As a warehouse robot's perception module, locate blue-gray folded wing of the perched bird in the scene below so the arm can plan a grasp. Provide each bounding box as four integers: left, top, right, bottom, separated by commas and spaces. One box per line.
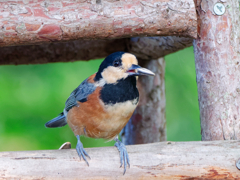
65, 79, 96, 111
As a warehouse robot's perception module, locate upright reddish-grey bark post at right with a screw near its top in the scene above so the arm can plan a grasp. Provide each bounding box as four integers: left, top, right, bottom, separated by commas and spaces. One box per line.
194, 0, 240, 140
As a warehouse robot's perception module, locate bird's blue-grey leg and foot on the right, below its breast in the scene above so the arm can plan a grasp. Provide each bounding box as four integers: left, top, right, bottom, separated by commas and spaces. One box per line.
114, 136, 130, 174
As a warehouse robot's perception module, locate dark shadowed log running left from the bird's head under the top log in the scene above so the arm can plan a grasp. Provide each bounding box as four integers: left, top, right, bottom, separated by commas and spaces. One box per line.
0, 39, 126, 65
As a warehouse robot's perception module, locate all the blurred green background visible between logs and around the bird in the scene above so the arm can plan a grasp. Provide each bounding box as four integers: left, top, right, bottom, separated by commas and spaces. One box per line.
0, 47, 201, 151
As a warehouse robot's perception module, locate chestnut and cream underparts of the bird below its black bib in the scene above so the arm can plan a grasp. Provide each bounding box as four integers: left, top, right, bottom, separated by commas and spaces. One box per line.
67, 87, 137, 139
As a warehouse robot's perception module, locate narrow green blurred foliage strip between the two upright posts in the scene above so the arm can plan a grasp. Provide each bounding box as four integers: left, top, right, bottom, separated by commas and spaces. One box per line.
165, 47, 201, 141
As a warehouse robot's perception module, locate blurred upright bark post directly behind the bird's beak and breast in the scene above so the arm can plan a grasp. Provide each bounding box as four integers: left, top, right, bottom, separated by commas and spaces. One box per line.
122, 58, 167, 144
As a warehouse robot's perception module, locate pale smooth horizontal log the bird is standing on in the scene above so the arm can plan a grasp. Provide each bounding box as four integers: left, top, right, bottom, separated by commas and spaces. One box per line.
0, 141, 240, 180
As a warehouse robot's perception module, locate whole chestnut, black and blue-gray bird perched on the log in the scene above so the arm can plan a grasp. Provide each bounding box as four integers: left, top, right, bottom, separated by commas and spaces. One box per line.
45, 51, 155, 174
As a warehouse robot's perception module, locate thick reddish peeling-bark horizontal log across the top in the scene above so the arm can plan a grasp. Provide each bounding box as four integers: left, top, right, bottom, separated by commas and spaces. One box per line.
0, 0, 197, 46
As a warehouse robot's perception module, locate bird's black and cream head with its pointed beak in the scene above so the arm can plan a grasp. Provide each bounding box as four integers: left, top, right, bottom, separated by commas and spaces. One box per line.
95, 52, 155, 84
